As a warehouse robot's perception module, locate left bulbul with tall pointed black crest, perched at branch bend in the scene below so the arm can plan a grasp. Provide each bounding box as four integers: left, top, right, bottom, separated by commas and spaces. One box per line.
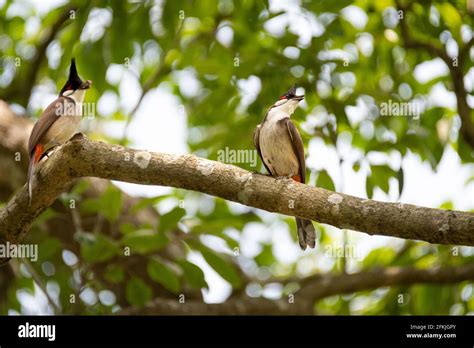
27, 58, 92, 203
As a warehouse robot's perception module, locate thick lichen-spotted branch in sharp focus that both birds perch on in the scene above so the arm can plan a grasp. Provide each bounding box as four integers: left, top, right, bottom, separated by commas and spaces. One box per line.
0, 137, 474, 250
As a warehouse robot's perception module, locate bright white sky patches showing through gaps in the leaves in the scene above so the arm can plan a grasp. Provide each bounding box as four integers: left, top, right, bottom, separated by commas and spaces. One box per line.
4, 0, 474, 313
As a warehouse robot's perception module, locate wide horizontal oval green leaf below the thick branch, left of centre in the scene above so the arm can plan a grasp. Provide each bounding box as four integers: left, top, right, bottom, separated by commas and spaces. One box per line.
121, 229, 169, 254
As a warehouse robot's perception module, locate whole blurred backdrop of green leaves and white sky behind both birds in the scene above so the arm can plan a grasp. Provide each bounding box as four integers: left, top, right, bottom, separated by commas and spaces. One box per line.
0, 0, 474, 315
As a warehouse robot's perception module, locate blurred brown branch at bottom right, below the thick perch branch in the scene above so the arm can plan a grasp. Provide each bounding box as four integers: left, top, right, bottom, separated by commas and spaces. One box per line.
118, 265, 474, 315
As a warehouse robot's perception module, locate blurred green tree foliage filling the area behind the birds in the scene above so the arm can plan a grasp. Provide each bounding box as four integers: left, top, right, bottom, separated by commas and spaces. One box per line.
0, 0, 474, 314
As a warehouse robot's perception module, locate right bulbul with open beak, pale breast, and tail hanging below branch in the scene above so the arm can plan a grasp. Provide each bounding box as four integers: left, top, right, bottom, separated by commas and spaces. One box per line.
253, 86, 316, 250
